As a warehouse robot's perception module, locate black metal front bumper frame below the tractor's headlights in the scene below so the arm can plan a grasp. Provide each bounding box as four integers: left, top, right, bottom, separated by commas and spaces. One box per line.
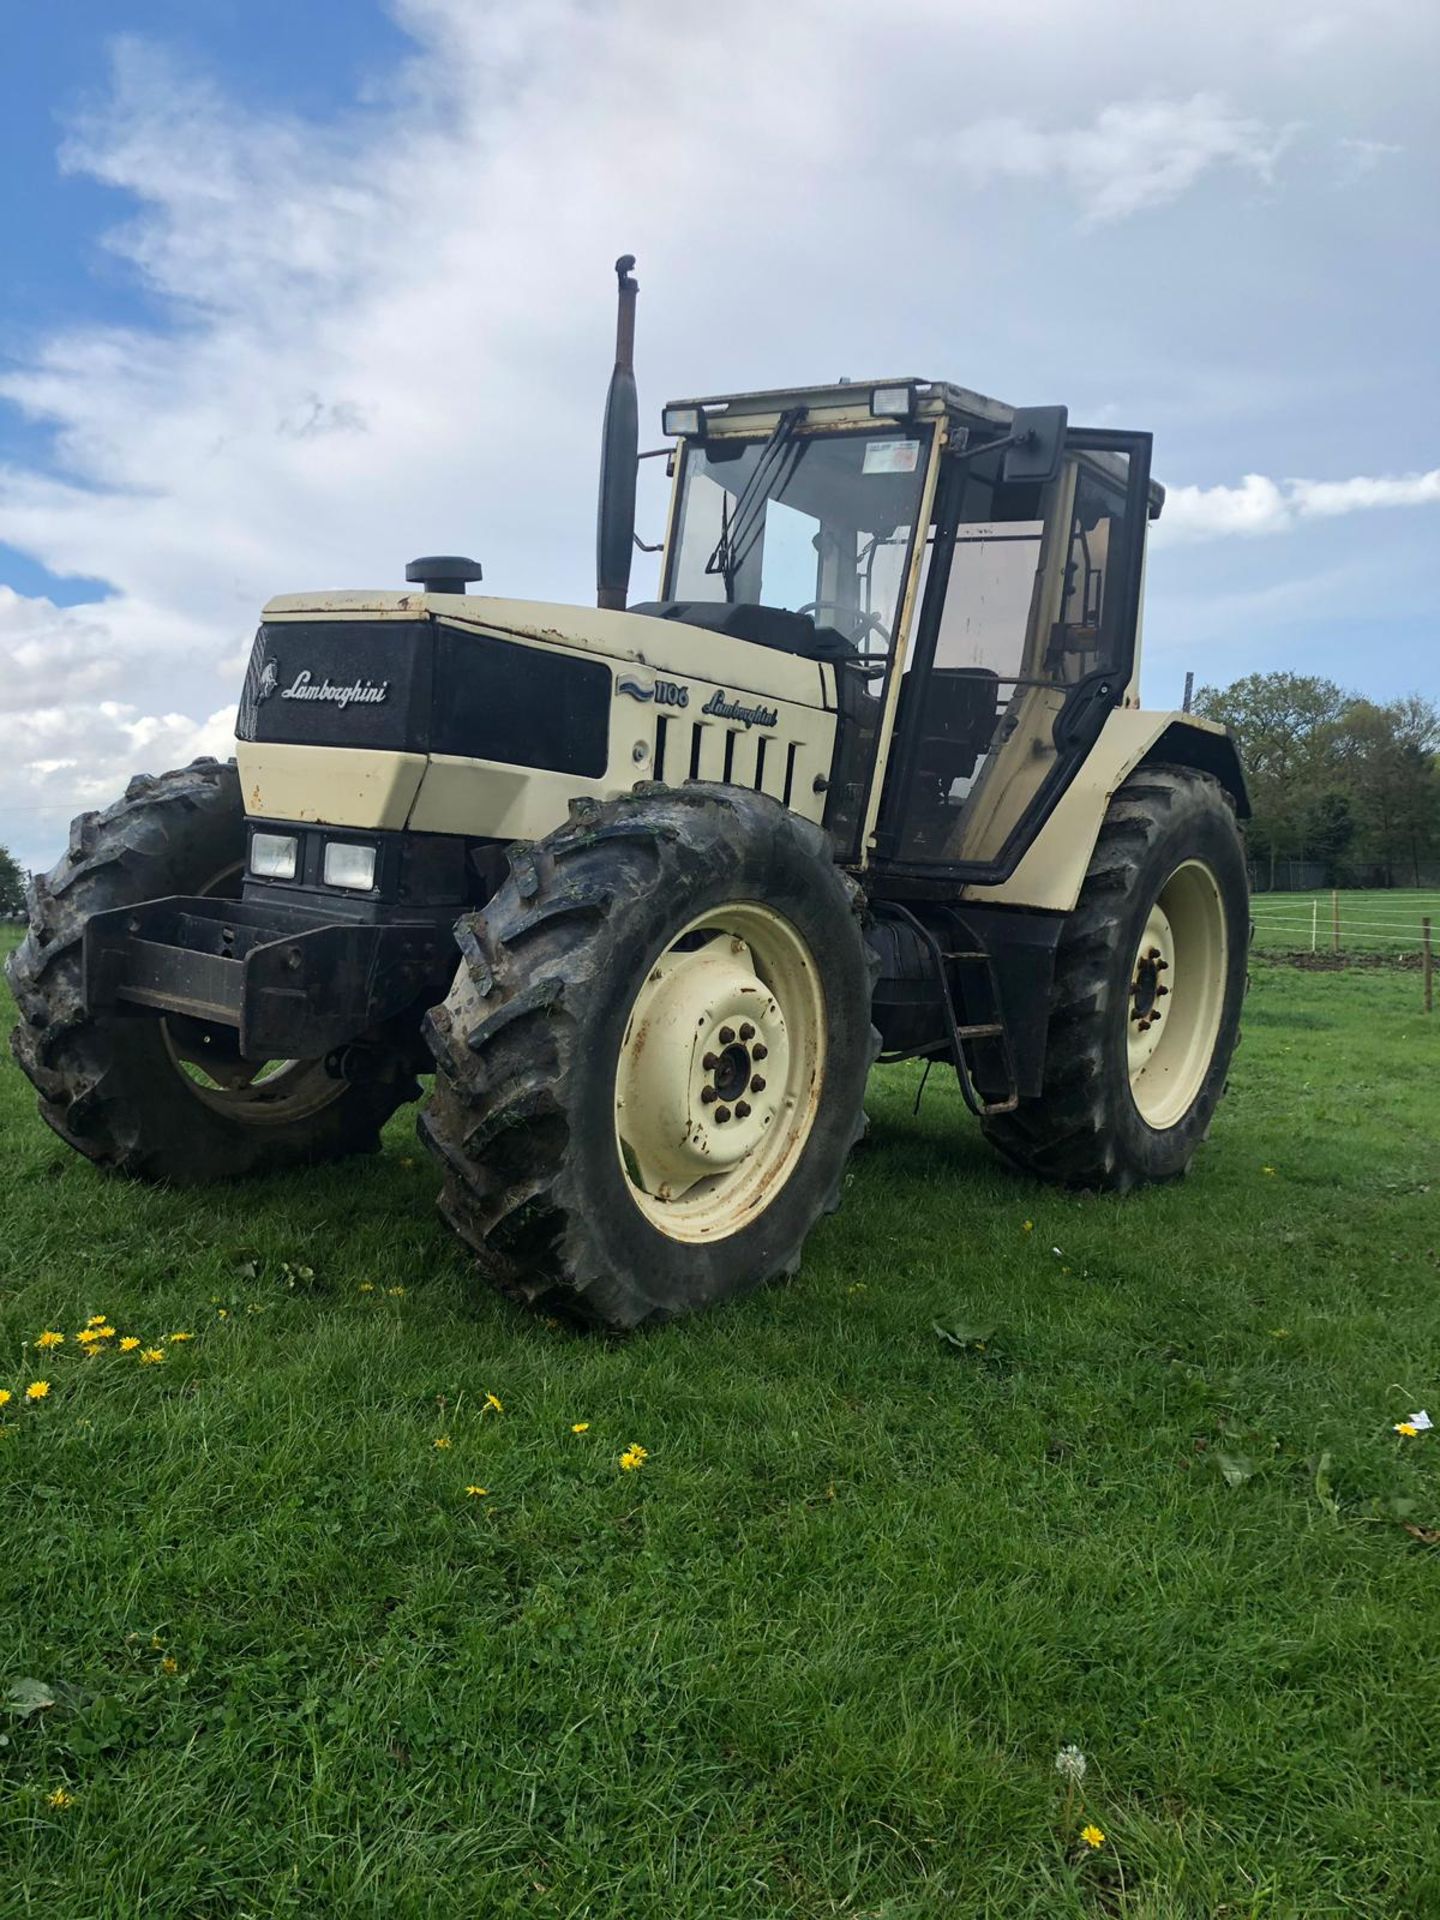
84, 897, 453, 1060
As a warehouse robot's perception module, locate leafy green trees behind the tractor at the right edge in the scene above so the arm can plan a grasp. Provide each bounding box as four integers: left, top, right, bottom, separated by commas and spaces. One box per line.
1194, 674, 1440, 887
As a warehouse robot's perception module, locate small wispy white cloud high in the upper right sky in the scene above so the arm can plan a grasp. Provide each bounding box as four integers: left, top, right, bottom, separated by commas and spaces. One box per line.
920, 92, 1290, 225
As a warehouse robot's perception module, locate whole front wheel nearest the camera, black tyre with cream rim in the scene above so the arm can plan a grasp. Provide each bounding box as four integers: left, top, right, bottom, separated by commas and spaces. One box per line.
420, 783, 879, 1329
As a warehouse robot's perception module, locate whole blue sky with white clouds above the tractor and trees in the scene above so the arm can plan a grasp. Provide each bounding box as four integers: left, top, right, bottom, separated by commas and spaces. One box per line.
0, 0, 1440, 868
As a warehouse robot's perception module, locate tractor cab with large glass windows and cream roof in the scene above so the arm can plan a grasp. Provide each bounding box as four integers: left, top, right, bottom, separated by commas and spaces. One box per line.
634, 378, 1164, 881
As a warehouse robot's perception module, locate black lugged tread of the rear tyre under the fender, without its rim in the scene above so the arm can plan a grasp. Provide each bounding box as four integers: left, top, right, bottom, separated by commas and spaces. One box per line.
981, 766, 1248, 1192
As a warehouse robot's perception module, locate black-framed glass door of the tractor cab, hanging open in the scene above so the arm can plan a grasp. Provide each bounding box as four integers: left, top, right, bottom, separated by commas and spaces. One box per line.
876, 428, 1150, 881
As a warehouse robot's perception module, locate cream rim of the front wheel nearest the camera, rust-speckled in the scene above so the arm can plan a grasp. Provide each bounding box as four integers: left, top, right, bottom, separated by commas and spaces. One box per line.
614, 900, 826, 1244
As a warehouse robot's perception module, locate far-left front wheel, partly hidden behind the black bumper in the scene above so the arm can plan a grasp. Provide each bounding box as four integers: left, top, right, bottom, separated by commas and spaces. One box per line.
6, 760, 420, 1185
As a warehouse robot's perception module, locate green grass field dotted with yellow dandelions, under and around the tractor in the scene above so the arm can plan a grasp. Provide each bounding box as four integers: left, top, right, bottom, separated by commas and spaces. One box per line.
0, 921, 1440, 1920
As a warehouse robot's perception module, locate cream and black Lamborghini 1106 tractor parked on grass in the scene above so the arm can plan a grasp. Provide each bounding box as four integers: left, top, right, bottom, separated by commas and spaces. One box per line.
8, 255, 1248, 1329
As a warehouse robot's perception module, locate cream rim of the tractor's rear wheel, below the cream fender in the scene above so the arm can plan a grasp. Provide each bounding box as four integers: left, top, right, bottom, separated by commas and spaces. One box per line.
1125, 860, 1229, 1133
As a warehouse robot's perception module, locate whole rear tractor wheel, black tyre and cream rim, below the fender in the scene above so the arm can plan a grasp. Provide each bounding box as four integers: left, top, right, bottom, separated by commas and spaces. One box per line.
981, 766, 1250, 1190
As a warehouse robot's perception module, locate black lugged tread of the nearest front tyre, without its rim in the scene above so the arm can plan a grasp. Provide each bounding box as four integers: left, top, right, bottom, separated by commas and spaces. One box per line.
419, 781, 879, 1329
